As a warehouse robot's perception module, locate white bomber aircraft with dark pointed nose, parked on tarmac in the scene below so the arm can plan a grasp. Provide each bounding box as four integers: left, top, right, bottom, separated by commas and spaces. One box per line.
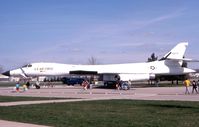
1, 43, 195, 81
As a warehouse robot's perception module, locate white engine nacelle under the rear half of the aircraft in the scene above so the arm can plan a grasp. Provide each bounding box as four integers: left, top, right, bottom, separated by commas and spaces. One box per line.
119, 73, 155, 81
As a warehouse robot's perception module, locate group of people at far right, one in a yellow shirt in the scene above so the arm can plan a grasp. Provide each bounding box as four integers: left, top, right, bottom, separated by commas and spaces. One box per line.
183, 79, 199, 94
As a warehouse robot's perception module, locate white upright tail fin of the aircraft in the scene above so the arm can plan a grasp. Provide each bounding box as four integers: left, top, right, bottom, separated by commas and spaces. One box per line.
160, 42, 188, 60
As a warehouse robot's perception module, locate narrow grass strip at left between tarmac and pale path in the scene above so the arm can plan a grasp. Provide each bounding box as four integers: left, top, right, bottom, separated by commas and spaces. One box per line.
0, 95, 67, 102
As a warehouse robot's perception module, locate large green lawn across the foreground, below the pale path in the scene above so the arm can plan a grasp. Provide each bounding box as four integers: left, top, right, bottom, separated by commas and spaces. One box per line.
0, 100, 199, 127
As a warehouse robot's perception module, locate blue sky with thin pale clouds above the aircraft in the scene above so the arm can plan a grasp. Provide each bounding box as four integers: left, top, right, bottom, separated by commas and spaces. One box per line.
0, 0, 199, 70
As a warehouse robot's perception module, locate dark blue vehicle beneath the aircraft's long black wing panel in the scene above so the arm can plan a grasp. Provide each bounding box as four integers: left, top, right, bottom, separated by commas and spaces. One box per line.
62, 77, 84, 86
